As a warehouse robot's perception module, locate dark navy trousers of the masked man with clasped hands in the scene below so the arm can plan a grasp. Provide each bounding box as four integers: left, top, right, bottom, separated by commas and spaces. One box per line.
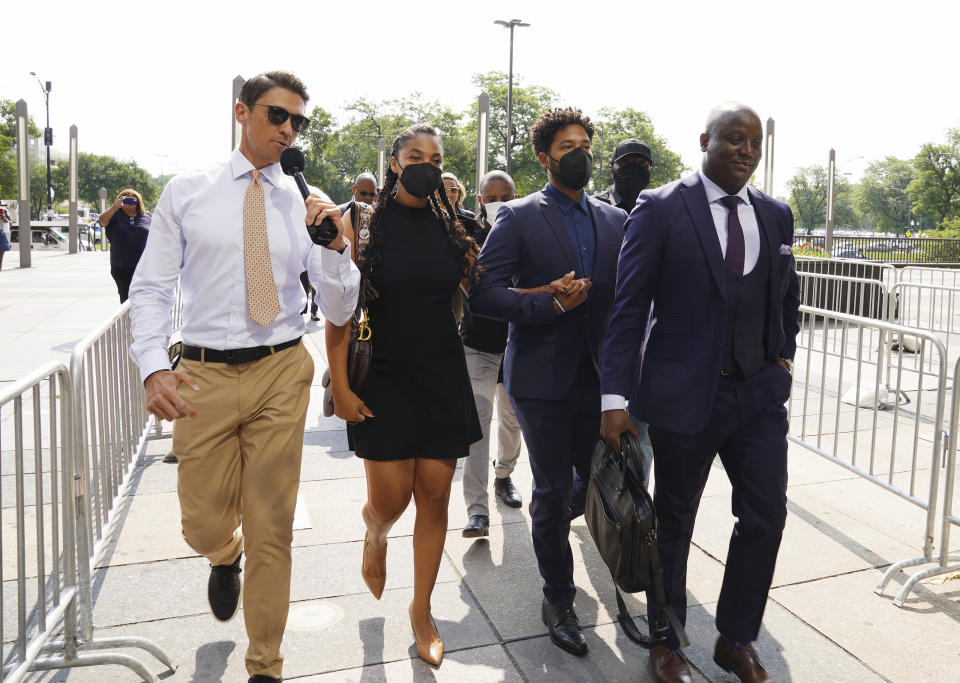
510, 360, 600, 605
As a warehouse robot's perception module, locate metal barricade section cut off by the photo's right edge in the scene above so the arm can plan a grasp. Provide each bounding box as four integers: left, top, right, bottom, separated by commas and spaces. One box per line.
874, 360, 960, 607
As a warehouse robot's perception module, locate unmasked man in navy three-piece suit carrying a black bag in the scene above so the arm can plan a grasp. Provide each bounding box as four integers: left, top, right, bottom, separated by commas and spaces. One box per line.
602, 103, 800, 681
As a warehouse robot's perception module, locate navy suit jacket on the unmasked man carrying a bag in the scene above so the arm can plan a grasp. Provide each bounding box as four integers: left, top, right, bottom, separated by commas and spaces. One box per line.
601, 173, 800, 434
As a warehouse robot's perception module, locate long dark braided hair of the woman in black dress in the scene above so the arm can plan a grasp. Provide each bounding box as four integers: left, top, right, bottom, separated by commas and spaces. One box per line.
360, 123, 478, 301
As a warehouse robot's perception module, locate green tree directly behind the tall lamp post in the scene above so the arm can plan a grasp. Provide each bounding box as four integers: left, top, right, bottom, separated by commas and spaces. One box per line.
464, 71, 558, 196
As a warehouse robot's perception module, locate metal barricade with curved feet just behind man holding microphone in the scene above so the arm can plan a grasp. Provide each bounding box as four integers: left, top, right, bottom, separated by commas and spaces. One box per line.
70, 302, 176, 683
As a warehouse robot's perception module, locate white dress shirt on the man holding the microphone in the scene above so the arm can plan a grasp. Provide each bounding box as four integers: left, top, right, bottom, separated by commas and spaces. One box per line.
130, 149, 360, 380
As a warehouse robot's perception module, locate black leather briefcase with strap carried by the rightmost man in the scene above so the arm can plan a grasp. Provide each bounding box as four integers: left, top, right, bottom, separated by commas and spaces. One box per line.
584, 433, 690, 648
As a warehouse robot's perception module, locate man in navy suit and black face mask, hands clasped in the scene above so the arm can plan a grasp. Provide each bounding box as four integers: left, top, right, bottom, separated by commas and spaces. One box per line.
469, 108, 626, 656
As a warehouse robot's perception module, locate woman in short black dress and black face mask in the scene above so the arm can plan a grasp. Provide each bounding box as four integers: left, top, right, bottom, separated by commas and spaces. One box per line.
326, 124, 481, 665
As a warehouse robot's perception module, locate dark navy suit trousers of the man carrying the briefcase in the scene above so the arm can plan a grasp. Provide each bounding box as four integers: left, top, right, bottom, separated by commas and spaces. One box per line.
647, 365, 790, 649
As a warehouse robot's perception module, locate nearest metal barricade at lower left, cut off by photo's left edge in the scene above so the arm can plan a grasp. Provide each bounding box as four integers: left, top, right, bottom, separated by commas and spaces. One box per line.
0, 363, 77, 683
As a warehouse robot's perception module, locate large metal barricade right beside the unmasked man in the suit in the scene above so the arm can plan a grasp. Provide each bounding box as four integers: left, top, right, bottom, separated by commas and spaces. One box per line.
788, 306, 947, 605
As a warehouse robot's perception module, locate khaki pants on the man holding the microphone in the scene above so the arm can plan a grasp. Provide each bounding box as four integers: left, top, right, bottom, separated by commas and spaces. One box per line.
173, 344, 313, 678
